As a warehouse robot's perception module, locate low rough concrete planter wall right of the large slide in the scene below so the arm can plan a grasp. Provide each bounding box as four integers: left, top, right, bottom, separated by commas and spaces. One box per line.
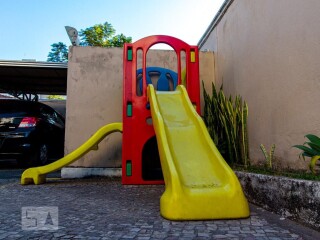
236, 172, 320, 230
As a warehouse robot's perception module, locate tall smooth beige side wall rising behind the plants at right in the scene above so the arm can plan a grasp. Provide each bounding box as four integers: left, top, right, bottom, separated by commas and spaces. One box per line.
201, 0, 320, 168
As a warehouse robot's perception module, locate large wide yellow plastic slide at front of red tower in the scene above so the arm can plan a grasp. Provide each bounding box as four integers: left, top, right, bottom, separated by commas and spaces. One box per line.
148, 85, 250, 220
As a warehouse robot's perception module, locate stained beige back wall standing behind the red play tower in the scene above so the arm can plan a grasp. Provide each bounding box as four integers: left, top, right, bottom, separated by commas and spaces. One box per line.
65, 47, 214, 168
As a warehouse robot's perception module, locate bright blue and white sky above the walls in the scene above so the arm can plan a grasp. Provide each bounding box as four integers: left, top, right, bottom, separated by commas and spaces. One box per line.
0, 0, 224, 61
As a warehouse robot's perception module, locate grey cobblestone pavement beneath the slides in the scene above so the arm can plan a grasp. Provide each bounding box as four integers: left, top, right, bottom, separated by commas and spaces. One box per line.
0, 178, 320, 240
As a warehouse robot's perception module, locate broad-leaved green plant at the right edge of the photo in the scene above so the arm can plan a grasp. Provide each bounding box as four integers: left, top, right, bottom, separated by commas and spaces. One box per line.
293, 134, 320, 174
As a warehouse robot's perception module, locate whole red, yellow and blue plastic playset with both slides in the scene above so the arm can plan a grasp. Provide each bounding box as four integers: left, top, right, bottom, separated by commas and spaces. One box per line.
21, 35, 250, 220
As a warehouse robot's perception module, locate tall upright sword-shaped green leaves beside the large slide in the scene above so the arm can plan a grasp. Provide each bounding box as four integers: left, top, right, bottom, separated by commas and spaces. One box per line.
202, 82, 250, 166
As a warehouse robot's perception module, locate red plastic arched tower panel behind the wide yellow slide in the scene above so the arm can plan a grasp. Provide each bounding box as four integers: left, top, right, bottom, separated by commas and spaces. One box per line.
122, 35, 200, 184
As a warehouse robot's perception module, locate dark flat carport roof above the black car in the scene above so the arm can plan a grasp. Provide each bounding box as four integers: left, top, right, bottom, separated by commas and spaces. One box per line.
0, 60, 68, 95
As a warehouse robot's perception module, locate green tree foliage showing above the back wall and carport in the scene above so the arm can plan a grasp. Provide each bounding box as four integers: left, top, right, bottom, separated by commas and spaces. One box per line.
47, 22, 132, 62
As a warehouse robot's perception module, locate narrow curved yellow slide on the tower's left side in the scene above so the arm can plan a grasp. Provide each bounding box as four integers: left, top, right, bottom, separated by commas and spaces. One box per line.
21, 123, 122, 185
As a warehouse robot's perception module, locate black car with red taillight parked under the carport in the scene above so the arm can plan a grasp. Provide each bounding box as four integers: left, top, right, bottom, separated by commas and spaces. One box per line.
0, 99, 65, 166
